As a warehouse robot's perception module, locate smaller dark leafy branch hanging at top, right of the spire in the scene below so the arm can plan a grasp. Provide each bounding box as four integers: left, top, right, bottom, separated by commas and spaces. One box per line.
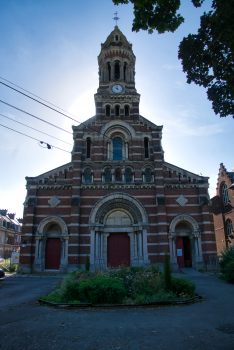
112, 0, 204, 34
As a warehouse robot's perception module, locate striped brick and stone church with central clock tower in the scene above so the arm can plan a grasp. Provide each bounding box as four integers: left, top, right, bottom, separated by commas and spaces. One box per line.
19, 26, 216, 272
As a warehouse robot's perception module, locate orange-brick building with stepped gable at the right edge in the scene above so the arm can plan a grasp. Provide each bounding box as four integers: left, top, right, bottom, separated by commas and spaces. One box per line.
211, 163, 234, 254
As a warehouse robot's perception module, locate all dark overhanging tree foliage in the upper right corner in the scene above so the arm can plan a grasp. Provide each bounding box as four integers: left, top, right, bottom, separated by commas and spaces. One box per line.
112, 0, 234, 118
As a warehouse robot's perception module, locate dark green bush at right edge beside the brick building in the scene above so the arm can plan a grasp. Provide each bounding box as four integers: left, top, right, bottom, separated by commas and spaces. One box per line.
220, 247, 234, 283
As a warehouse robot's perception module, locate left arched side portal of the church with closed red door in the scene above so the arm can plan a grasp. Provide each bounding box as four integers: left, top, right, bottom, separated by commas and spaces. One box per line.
33, 216, 69, 271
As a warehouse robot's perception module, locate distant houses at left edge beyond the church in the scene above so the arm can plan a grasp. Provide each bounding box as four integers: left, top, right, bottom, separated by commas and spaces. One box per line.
0, 209, 23, 259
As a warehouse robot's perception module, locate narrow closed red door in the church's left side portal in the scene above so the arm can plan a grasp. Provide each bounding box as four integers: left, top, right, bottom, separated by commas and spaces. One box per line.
45, 238, 61, 270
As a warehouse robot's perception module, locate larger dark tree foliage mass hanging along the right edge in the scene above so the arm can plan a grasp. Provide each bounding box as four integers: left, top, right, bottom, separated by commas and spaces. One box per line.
179, 0, 234, 118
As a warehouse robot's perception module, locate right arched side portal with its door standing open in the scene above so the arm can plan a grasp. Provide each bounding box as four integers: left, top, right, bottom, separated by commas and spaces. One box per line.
169, 215, 203, 270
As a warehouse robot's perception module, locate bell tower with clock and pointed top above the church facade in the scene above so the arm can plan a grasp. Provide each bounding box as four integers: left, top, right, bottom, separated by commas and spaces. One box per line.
94, 26, 140, 121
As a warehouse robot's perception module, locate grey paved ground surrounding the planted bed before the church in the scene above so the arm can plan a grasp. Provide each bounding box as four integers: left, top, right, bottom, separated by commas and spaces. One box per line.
0, 275, 234, 350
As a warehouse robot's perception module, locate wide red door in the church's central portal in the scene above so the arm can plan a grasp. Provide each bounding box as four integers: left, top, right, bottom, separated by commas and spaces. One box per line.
107, 232, 130, 268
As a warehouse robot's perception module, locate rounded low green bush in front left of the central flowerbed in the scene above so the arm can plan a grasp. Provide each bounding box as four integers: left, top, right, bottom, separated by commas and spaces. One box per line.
79, 276, 126, 304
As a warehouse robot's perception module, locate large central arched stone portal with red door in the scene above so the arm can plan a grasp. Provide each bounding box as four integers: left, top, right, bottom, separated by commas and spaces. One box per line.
89, 193, 149, 268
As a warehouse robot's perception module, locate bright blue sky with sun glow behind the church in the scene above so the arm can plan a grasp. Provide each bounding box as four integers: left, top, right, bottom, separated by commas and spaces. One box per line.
0, 0, 234, 217
